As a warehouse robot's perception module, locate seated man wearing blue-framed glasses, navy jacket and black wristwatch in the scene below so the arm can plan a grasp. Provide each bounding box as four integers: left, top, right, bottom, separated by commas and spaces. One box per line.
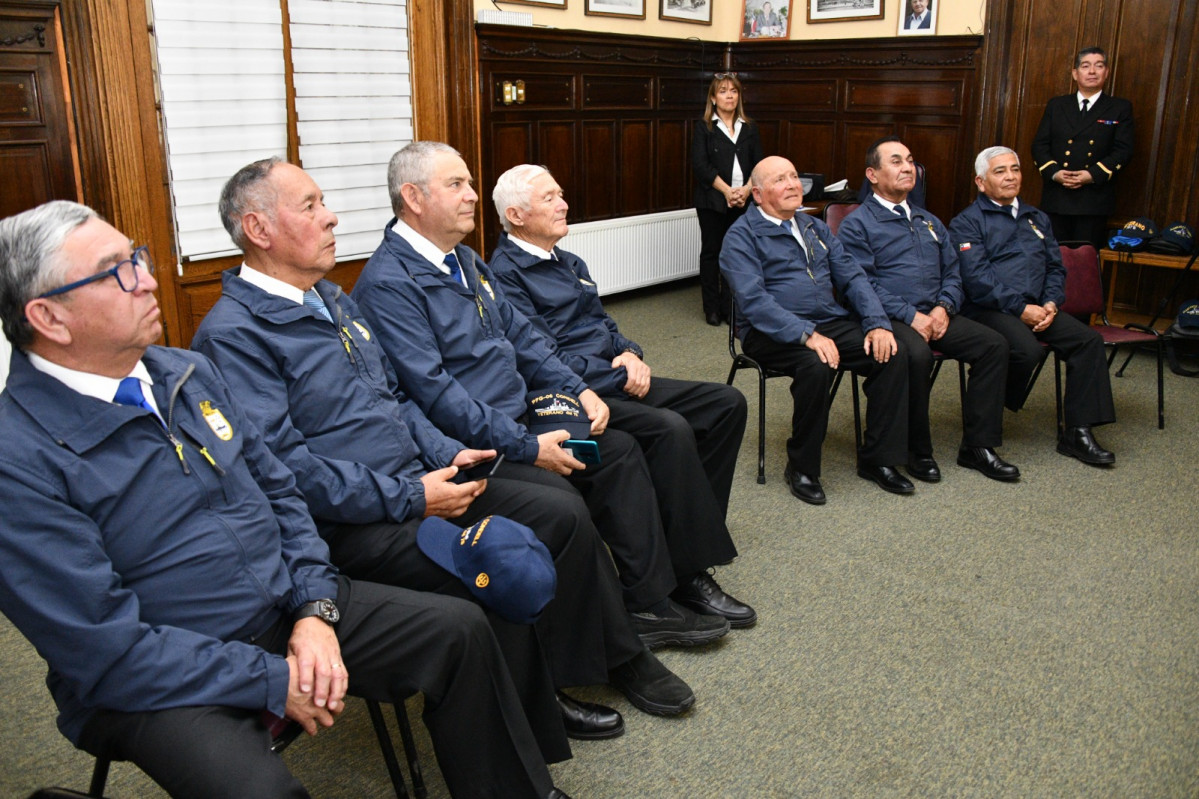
0, 202, 565, 799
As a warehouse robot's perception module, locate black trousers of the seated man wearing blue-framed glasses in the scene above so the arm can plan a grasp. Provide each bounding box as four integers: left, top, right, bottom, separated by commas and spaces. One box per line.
80, 577, 553, 799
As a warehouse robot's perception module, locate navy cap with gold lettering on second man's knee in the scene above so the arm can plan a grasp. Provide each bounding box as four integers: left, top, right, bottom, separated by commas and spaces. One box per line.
416, 516, 558, 624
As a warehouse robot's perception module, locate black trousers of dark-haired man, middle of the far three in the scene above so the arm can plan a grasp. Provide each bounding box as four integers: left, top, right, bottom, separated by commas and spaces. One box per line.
891, 317, 1007, 456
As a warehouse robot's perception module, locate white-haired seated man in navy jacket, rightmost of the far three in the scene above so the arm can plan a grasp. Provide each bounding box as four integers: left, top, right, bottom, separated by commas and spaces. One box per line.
950, 146, 1116, 465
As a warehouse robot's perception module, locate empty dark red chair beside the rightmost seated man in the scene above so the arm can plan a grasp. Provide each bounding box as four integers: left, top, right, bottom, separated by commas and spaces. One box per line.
1054, 244, 1165, 429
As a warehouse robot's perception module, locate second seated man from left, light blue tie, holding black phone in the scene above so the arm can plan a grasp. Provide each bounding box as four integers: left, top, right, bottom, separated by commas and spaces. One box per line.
192, 158, 689, 738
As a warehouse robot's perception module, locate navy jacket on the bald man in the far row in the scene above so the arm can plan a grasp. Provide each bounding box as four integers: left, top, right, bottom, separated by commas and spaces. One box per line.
721, 208, 891, 344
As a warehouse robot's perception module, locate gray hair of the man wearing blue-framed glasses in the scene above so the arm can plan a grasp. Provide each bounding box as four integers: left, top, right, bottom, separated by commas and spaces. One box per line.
0, 200, 100, 349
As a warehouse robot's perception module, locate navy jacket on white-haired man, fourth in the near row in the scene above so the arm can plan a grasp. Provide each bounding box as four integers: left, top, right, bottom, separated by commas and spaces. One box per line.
488, 233, 644, 397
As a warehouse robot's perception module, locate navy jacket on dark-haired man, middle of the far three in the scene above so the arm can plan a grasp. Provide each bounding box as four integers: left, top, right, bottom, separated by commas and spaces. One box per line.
837, 194, 963, 325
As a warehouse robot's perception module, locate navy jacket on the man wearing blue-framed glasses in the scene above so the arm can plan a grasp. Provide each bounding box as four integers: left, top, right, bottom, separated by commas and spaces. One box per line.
0, 347, 337, 743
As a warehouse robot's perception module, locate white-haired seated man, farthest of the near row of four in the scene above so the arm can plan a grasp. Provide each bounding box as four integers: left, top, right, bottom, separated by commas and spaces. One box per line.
488, 164, 758, 627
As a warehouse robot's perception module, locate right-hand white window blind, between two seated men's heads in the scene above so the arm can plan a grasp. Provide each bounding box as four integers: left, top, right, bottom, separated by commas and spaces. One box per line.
288, 0, 412, 260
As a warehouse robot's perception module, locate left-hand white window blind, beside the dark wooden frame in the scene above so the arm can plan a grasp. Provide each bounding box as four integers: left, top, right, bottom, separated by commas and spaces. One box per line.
152, 0, 288, 258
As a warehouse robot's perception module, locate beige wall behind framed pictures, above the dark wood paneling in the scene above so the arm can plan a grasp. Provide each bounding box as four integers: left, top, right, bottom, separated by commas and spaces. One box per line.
475, 0, 987, 42
